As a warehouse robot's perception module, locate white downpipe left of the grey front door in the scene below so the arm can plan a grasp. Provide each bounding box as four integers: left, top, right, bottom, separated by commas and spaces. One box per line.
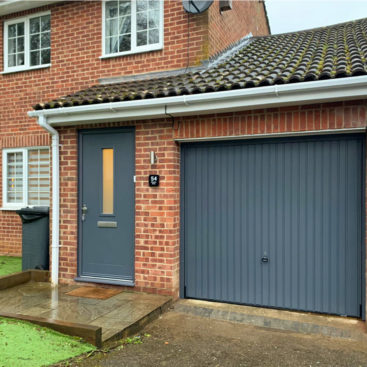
38, 115, 60, 287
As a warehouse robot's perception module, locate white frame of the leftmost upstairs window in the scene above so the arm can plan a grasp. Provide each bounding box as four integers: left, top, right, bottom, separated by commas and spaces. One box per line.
1, 11, 52, 74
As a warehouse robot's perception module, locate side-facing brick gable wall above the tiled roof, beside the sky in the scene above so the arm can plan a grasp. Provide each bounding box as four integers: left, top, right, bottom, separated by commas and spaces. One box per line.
208, 0, 269, 56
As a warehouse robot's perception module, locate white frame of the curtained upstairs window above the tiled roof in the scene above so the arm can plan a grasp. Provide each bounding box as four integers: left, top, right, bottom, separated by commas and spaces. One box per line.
100, 0, 164, 59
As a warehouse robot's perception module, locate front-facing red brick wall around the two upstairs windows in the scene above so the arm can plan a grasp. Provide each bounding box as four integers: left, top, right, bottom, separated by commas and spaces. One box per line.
0, 0, 268, 254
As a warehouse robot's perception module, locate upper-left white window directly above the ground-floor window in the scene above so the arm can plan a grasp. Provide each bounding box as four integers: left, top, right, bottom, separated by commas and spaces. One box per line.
4, 13, 51, 72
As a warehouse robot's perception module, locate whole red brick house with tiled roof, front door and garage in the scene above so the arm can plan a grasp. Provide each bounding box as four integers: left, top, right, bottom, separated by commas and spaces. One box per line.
0, 0, 367, 318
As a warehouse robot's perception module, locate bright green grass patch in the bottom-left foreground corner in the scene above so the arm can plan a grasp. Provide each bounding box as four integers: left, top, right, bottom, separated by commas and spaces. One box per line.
0, 317, 95, 367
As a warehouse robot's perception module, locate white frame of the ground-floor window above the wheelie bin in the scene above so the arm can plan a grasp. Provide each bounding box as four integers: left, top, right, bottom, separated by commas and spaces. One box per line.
1, 146, 51, 210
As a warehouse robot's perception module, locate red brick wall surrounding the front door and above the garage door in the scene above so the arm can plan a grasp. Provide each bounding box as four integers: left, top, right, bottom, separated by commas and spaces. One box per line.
53, 101, 367, 297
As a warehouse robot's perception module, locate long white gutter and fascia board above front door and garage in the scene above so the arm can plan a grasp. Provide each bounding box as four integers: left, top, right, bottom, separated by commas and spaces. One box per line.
28, 76, 367, 126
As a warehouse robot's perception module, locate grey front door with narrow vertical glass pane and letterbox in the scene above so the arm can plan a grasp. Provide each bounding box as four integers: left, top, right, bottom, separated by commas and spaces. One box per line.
78, 128, 135, 285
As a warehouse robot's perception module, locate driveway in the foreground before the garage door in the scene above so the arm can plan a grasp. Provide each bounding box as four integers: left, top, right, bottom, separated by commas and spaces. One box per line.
59, 311, 367, 367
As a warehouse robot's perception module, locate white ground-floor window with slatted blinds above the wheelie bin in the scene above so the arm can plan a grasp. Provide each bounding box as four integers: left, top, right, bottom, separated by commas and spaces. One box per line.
3, 148, 50, 209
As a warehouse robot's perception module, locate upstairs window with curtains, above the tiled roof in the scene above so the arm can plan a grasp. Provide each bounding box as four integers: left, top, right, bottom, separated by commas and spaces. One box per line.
103, 0, 163, 56
